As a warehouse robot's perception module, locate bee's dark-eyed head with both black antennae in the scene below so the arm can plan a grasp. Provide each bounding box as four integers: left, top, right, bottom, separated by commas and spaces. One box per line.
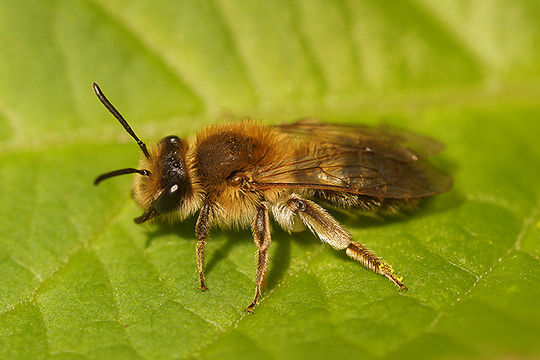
92, 83, 192, 224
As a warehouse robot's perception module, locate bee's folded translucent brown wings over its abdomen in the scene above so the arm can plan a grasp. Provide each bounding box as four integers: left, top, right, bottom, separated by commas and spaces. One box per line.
252, 120, 452, 199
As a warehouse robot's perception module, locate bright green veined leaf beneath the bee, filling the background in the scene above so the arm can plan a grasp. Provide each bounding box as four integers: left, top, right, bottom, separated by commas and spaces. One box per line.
0, 0, 540, 359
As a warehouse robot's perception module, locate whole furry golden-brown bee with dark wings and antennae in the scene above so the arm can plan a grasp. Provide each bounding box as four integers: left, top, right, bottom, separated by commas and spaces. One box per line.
93, 83, 452, 312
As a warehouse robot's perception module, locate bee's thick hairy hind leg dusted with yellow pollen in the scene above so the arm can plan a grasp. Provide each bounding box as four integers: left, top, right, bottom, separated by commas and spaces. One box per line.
287, 195, 407, 290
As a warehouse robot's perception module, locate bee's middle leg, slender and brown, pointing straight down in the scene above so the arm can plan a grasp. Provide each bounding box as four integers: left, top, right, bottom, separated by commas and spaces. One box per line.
246, 204, 272, 312
